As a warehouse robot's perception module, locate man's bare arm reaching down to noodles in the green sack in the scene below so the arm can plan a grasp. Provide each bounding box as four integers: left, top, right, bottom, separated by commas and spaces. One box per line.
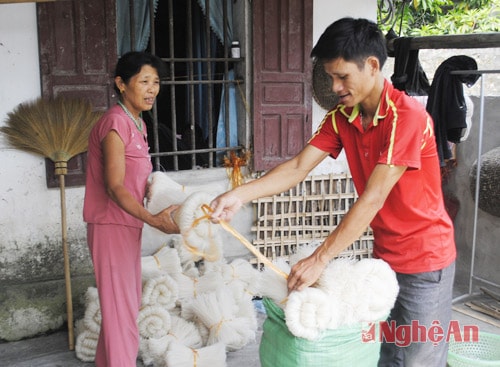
288, 164, 407, 291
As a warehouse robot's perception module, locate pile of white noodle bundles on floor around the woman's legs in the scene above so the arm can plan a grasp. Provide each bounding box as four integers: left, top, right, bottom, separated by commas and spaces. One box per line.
76, 187, 264, 367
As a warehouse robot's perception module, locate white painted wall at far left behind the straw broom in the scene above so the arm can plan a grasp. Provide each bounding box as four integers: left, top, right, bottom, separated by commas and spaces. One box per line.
0, 3, 87, 262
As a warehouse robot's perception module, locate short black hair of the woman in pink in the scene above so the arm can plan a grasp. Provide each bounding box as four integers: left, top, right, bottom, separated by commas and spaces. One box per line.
115, 51, 167, 93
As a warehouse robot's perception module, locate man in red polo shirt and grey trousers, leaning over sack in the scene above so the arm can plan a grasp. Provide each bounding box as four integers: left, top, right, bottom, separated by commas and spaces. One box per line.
212, 18, 456, 367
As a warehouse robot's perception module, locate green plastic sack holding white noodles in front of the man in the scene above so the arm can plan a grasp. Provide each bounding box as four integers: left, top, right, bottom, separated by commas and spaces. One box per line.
259, 298, 381, 367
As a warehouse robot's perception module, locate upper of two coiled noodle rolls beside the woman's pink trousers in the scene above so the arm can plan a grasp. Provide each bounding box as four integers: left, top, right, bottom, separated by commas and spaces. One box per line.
142, 274, 179, 310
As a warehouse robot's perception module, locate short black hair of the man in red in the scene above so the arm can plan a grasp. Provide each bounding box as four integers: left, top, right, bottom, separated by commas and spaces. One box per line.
311, 17, 387, 68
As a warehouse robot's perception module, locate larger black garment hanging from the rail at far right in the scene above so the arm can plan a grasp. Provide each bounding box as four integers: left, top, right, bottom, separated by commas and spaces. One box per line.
426, 55, 479, 166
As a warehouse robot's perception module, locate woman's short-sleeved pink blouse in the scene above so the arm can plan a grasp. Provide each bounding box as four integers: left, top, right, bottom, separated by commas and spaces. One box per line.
83, 105, 153, 228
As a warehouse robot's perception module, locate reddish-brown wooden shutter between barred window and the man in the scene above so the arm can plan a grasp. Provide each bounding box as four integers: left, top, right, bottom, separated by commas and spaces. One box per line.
252, 0, 313, 170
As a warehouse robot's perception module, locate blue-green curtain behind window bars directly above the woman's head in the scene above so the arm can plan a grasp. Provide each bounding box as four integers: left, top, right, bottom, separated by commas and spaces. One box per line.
116, 0, 158, 56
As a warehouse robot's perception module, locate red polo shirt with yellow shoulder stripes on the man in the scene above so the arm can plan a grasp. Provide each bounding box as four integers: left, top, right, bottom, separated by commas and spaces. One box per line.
309, 80, 456, 273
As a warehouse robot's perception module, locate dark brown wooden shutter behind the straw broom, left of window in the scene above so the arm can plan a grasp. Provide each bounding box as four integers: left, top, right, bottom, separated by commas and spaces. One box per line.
37, 0, 117, 187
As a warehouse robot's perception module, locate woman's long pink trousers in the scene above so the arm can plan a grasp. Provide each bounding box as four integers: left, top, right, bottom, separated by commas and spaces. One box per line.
87, 223, 142, 367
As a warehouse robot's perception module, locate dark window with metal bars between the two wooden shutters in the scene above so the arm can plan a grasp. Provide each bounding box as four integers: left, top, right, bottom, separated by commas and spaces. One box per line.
124, 0, 244, 171
